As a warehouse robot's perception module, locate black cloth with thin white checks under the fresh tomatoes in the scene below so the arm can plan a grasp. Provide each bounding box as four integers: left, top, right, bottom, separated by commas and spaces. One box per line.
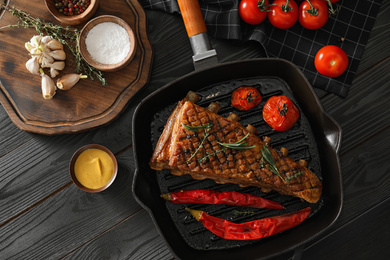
139, 0, 382, 97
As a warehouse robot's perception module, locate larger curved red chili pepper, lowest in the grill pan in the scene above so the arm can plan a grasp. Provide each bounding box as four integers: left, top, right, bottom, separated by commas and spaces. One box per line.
186, 207, 311, 240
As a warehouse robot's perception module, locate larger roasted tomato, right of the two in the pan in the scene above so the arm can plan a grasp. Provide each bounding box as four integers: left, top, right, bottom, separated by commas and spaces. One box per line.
263, 96, 299, 132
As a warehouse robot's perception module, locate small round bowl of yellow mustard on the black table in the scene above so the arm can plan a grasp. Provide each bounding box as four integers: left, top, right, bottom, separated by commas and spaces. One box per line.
69, 144, 118, 193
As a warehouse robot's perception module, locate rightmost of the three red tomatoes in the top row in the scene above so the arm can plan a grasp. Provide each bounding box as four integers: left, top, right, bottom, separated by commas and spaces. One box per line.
298, 0, 329, 30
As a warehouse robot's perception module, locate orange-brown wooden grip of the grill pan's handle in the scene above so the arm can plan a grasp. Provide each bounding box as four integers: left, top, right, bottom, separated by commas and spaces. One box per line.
177, 0, 207, 37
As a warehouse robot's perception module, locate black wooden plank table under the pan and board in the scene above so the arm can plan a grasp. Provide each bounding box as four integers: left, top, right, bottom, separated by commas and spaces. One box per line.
0, 1, 390, 259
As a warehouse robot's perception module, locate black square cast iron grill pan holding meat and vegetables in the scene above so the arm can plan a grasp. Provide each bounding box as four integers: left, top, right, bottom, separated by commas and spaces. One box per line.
132, 1, 343, 259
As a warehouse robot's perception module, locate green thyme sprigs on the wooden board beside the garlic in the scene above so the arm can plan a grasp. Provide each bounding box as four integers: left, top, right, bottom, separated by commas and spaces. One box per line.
0, 4, 107, 86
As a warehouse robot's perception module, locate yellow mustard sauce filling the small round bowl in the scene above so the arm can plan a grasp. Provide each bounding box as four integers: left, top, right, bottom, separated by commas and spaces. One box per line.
74, 148, 114, 189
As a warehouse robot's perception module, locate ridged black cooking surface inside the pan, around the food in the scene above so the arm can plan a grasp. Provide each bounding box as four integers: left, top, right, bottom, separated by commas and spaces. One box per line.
151, 77, 322, 250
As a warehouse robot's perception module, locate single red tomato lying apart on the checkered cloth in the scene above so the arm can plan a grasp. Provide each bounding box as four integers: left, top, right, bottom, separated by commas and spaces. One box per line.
314, 45, 348, 78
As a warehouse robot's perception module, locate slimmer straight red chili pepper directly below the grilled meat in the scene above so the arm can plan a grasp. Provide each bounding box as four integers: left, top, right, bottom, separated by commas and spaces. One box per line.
161, 189, 284, 209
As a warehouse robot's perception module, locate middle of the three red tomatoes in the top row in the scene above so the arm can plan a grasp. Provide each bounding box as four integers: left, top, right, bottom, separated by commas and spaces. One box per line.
268, 0, 298, 29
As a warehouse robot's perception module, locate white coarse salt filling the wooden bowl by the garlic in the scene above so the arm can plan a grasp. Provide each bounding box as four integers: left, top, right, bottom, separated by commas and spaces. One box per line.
85, 22, 130, 64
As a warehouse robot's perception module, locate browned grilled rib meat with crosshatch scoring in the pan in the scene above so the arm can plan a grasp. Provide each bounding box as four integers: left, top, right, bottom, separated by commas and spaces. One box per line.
150, 101, 322, 203
